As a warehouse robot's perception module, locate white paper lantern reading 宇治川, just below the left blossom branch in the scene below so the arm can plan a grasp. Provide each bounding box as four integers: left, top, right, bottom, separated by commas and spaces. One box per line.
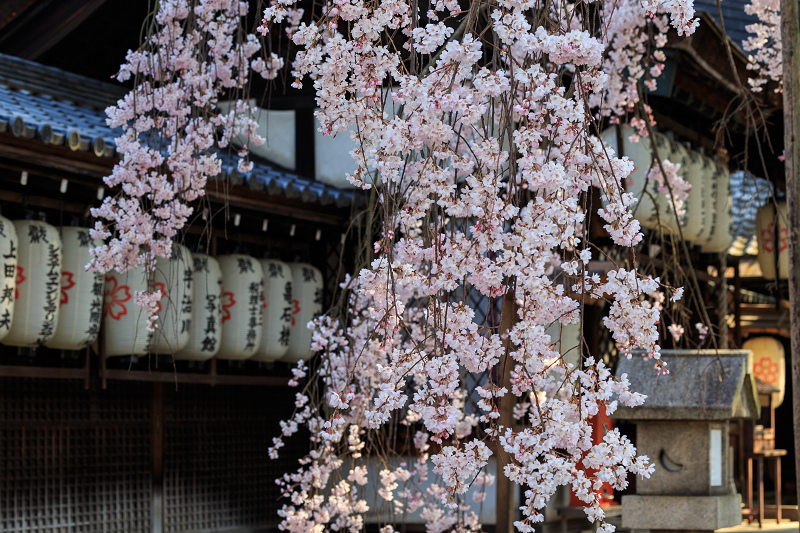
150, 245, 193, 354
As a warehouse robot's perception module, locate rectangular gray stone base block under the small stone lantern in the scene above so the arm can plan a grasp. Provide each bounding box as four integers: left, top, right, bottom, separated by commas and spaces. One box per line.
622, 494, 742, 530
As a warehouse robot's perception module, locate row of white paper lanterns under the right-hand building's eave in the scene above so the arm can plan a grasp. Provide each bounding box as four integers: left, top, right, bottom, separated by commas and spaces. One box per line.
602, 125, 733, 253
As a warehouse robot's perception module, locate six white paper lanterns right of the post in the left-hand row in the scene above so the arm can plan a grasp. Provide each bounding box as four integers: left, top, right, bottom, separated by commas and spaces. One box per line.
103, 250, 322, 361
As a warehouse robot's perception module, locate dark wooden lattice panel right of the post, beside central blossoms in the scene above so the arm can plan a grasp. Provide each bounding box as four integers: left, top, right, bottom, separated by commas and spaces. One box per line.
164, 385, 303, 532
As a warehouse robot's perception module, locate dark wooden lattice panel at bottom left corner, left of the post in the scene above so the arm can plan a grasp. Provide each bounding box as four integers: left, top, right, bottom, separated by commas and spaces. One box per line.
0, 379, 151, 533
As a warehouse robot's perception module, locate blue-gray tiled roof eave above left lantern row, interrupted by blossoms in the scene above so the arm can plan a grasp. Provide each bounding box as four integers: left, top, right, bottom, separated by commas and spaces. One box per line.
0, 54, 364, 207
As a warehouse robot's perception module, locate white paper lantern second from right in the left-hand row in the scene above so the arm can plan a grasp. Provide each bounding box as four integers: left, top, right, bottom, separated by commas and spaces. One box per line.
253, 259, 294, 361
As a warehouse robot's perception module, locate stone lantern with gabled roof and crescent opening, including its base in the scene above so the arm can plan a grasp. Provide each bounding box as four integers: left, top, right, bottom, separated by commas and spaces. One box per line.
614, 350, 760, 531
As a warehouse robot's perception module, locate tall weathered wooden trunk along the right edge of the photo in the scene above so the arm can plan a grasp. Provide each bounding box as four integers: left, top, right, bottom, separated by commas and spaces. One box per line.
781, 0, 800, 516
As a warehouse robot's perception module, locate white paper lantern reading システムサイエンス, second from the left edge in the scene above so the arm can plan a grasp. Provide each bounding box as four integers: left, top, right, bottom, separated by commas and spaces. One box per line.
3, 220, 62, 347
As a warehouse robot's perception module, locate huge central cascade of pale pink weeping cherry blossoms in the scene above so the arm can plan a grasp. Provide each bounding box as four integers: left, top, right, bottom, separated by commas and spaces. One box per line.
259, 0, 696, 532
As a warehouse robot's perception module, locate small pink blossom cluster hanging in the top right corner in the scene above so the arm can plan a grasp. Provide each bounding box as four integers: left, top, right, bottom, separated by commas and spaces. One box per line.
742, 0, 783, 92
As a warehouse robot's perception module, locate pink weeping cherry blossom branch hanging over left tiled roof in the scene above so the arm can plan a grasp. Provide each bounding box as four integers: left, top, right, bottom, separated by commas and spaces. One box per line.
88, 0, 268, 328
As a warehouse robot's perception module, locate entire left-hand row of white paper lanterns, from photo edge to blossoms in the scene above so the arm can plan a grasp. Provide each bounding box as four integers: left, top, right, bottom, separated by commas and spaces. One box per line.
0, 217, 323, 361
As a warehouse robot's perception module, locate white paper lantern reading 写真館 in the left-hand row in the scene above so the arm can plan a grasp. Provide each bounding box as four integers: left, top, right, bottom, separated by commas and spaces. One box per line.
172, 254, 222, 361
